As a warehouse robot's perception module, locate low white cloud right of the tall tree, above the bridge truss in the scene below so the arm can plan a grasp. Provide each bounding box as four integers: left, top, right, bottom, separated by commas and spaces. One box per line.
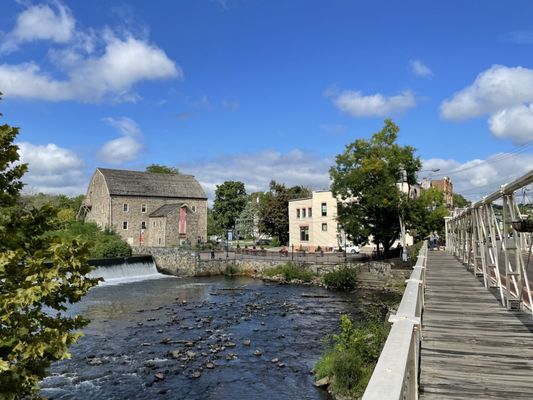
420, 153, 533, 201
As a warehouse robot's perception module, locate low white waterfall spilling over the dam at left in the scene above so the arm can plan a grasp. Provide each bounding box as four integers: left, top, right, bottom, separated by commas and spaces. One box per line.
89, 256, 169, 286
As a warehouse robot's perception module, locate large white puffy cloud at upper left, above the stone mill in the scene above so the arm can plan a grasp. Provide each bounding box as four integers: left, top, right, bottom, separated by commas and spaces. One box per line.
0, 37, 182, 102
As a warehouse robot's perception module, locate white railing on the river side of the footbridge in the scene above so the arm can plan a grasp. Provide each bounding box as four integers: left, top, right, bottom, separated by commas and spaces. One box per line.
363, 244, 427, 400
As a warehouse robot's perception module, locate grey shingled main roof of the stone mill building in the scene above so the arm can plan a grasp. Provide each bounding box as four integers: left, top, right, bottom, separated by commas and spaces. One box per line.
97, 168, 207, 199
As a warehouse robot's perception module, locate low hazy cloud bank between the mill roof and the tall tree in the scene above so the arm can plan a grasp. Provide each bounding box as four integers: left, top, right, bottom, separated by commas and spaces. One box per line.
179, 150, 334, 201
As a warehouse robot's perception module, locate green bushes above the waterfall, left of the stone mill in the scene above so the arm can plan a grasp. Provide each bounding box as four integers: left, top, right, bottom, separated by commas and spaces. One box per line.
47, 221, 131, 258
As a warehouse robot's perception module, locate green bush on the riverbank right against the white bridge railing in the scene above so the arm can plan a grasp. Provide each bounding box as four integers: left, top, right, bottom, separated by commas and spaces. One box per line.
315, 315, 390, 398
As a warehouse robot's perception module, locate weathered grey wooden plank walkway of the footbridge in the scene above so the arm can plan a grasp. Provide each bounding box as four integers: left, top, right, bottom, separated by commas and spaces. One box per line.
420, 251, 533, 400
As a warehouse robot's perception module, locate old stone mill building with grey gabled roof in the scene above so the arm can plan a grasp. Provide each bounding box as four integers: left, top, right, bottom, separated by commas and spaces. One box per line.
79, 168, 207, 247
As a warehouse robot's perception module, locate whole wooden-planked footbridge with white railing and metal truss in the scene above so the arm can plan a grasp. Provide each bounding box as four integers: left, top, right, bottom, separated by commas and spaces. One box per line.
363, 171, 533, 400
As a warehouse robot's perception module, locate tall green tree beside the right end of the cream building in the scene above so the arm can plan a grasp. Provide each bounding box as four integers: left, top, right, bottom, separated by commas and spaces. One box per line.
330, 119, 421, 253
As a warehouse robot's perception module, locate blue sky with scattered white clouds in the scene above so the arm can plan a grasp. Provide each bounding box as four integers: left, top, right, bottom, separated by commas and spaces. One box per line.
0, 0, 533, 200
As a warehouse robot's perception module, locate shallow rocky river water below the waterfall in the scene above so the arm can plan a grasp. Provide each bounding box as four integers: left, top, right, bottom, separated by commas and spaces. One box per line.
41, 277, 382, 399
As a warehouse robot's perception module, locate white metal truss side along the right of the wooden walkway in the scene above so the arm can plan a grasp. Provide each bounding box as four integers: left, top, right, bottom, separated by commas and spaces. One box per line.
446, 170, 533, 311
